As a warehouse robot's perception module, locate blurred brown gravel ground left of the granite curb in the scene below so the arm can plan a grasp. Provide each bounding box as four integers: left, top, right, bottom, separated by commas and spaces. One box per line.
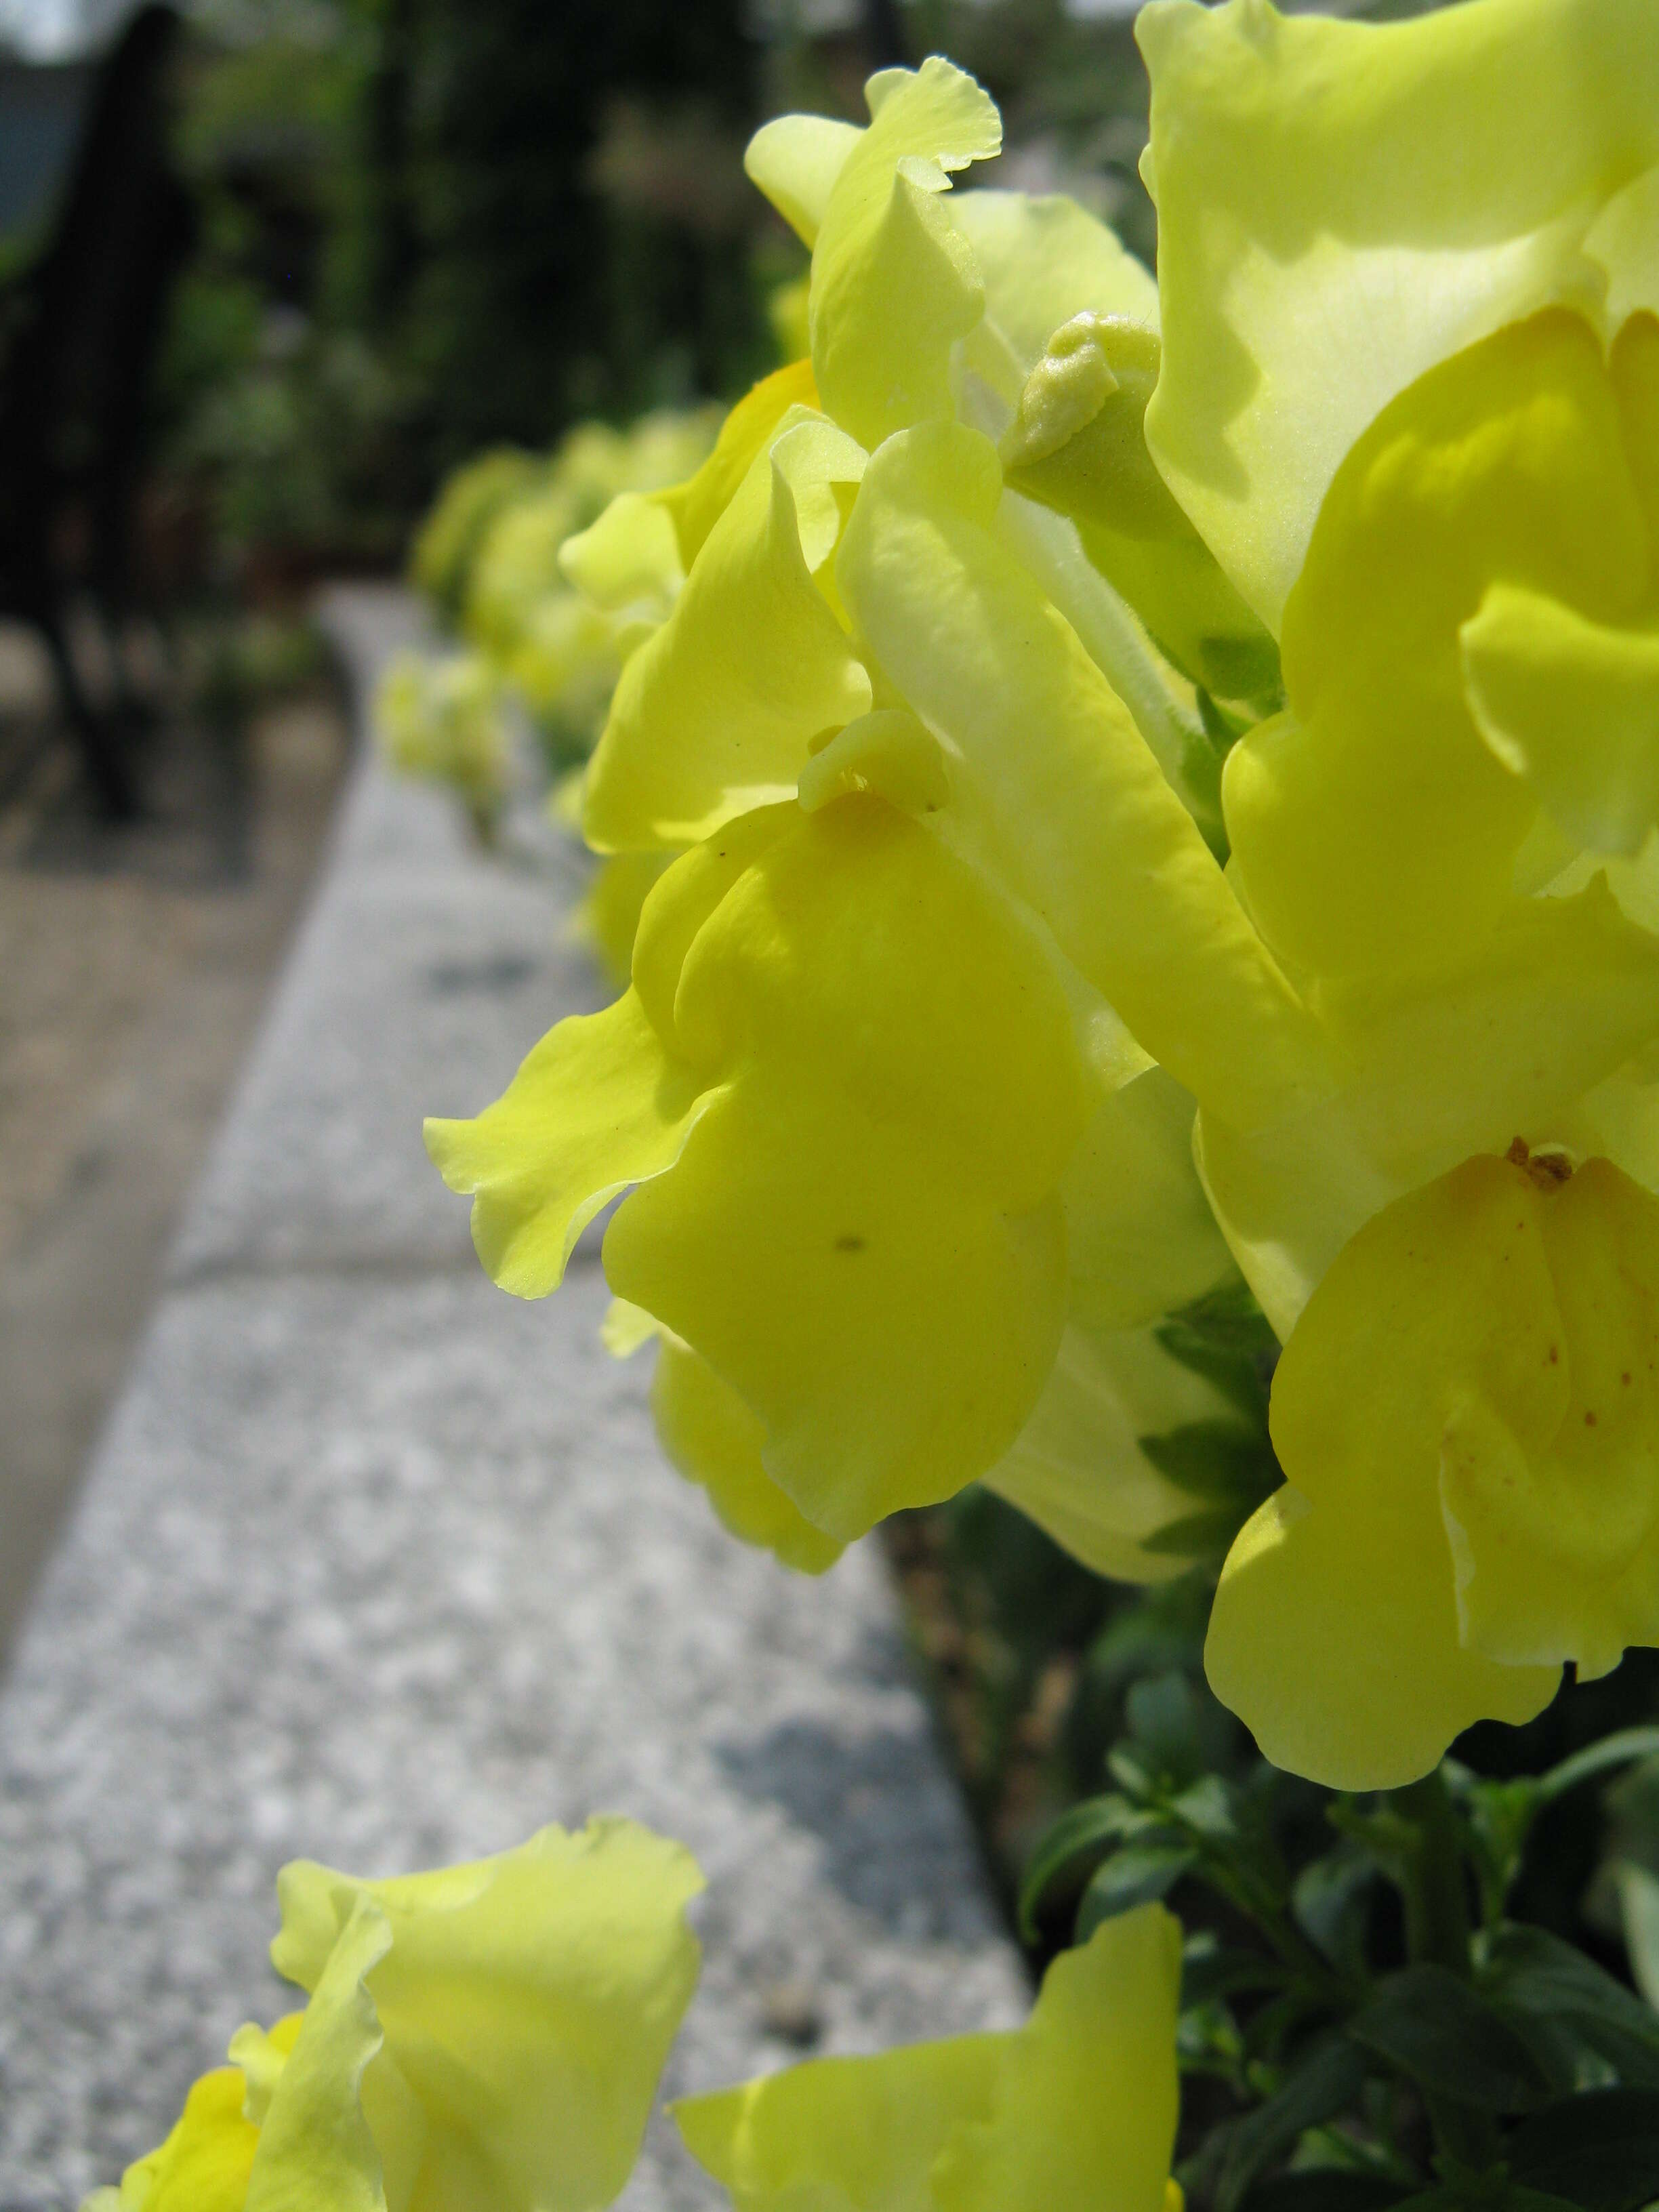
0, 630, 345, 1657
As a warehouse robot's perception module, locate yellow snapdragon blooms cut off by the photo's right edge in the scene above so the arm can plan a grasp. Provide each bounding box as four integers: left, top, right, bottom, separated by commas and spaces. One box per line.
1139, 0, 1659, 1787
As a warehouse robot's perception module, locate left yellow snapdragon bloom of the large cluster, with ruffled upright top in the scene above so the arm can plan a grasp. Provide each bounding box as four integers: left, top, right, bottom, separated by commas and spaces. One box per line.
429, 60, 1274, 1577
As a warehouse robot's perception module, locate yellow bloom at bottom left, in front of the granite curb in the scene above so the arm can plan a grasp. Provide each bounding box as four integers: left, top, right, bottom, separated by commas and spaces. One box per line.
84, 1818, 703, 2212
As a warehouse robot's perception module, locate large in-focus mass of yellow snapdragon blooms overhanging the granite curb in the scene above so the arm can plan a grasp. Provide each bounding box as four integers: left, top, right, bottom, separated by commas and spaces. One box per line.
429, 0, 1659, 1787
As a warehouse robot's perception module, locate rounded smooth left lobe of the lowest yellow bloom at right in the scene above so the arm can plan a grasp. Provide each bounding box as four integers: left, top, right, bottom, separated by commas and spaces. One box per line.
1206, 1159, 1566, 1790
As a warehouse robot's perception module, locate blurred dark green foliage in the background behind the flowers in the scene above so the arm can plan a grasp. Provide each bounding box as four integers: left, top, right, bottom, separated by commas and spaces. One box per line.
0, 0, 1153, 597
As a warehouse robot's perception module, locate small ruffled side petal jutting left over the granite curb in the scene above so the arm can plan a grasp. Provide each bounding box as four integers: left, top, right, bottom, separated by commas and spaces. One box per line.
425, 991, 701, 1298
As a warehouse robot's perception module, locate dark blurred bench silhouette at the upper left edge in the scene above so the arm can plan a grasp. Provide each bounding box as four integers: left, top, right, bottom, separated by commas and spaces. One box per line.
0, 5, 192, 816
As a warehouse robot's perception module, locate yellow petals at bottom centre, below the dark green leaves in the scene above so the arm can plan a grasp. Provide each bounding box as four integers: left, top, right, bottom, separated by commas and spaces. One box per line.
672, 1904, 1181, 2212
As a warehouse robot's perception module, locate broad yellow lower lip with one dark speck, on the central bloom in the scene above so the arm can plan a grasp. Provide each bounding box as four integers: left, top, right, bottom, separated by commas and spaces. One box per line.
606, 798, 1086, 1540
